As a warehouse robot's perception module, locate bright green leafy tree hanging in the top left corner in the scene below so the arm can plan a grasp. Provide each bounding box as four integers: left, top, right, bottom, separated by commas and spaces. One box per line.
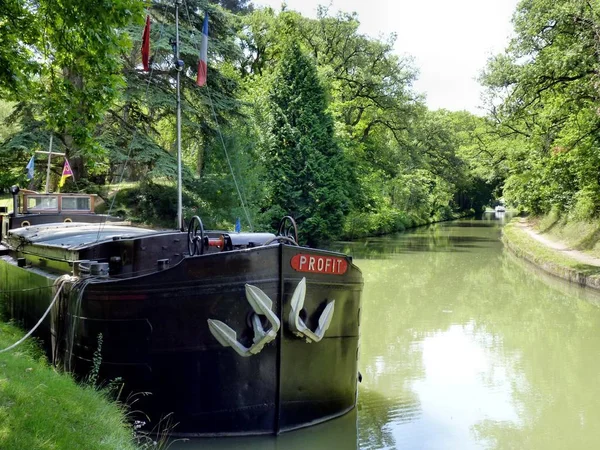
0, 0, 143, 186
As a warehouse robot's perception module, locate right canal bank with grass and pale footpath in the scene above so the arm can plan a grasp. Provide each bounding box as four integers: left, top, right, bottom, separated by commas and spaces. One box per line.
502, 217, 600, 290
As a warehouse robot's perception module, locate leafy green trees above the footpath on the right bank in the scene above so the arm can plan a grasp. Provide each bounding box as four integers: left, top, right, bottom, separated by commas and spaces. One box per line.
482, 0, 600, 220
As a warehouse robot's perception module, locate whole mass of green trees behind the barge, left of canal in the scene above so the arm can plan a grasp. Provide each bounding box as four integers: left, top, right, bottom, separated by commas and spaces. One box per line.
0, 0, 511, 244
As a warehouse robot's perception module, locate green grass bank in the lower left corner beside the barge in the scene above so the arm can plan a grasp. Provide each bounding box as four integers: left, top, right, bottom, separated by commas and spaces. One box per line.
0, 322, 136, 450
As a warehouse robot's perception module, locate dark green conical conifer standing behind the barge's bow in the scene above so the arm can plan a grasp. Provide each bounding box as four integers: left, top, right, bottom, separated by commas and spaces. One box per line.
266, 43, 349, 244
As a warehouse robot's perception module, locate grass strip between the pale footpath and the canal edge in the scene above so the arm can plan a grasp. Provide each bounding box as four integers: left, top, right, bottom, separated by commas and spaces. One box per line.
502, 219, 600, 289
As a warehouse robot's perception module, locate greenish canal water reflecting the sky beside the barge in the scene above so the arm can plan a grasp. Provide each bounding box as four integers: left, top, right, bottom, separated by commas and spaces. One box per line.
171, 214, 600, 450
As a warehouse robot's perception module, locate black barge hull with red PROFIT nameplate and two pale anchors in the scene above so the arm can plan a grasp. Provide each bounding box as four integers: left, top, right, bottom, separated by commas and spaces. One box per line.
0, 227, 363, 436
